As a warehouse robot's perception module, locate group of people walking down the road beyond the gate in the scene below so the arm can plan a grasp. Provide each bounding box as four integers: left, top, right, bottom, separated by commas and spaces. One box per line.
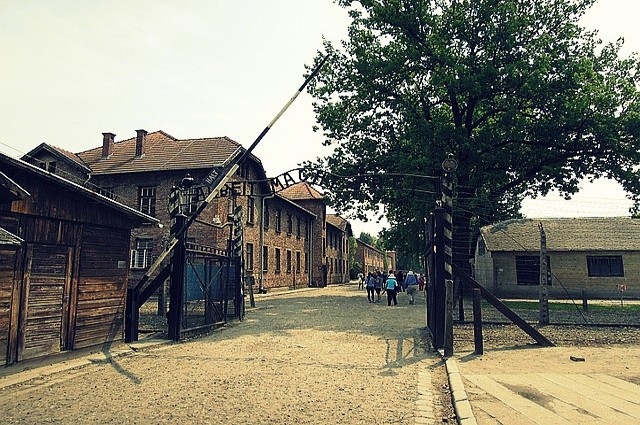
358, 270, 425, 306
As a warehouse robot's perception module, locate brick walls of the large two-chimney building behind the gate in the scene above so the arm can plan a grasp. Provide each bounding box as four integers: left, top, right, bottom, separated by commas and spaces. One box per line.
92, 160, 324, 288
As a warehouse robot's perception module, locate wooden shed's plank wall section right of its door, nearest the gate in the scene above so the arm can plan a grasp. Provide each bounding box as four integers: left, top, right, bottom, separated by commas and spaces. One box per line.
73, 225, 130, 348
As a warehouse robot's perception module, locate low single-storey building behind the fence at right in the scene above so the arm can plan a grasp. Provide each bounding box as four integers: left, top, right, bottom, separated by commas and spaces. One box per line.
474, 217, 640, 298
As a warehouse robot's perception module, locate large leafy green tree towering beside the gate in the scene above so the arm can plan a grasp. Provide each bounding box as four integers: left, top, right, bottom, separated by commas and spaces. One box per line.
307, 0, 640, 265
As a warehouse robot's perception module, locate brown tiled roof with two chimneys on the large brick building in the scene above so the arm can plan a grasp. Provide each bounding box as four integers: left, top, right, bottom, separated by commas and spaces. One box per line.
78, 131, 244, 175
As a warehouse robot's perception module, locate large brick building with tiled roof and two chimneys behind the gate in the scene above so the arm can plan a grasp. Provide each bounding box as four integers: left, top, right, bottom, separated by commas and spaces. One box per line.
23, 130, 350, 288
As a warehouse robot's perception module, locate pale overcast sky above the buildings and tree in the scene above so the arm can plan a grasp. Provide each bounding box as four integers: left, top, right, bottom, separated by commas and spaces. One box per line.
0, 0, 640, 235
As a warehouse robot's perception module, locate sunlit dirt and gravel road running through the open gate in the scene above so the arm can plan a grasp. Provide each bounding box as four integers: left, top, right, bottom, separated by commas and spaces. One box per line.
0, 285, 451, 425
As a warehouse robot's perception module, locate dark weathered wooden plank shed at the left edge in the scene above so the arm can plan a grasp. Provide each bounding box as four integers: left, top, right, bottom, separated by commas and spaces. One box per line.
0, 169, 138, 363
